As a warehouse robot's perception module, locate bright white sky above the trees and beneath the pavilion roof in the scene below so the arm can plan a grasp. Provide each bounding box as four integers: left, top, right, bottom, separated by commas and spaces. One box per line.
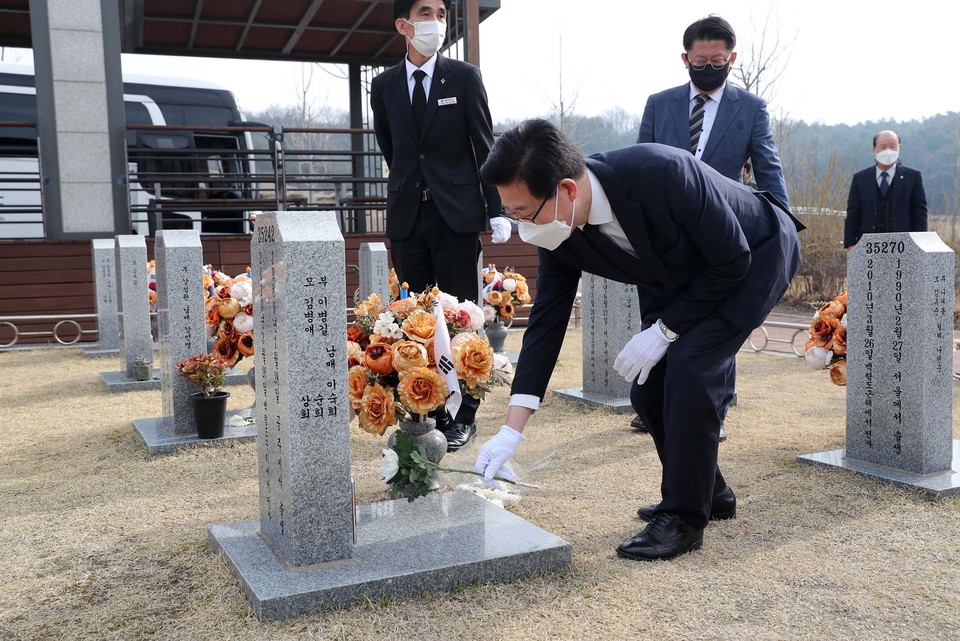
3, 0, 960, 124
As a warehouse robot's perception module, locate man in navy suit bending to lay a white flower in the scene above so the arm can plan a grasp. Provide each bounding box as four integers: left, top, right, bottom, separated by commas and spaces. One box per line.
476, 120, 803, 560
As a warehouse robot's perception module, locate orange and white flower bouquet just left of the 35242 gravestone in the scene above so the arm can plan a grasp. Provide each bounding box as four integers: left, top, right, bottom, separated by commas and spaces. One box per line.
203, 265, 254, 367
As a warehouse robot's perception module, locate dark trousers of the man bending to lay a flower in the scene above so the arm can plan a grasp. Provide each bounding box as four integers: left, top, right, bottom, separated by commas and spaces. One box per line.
630, 314, 750, 529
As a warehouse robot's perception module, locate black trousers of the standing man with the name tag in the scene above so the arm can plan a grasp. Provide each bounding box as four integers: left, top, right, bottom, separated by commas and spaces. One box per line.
390, 200, 480, 303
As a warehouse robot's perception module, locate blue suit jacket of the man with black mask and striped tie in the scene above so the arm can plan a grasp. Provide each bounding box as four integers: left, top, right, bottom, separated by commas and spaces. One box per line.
637, 82, 790, 208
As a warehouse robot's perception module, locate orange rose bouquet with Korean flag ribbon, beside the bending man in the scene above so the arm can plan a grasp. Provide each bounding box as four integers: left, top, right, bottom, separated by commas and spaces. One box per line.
347, 277, 494, 434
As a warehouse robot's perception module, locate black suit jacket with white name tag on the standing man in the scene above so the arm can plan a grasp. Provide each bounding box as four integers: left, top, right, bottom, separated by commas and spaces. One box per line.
370, 56, 500, 240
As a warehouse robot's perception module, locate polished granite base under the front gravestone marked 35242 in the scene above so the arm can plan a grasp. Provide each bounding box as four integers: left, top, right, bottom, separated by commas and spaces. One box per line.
208, 491, 571, 620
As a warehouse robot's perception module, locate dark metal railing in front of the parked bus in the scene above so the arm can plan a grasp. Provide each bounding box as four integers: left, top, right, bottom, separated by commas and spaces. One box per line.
0, 122, 387, 238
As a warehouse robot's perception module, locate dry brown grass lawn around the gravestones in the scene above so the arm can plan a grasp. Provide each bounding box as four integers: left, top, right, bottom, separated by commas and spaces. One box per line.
0, 331, 960, 641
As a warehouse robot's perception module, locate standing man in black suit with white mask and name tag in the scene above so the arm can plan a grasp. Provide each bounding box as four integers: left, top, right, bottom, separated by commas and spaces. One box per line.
370, 0, 511, 452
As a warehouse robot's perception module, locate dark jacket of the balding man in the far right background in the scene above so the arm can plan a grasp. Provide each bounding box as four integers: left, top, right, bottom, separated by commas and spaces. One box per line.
843, 162, 927, 247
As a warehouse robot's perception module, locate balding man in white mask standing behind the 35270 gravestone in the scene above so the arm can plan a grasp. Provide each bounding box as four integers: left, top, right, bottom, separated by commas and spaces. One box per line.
843, 130, 927, 249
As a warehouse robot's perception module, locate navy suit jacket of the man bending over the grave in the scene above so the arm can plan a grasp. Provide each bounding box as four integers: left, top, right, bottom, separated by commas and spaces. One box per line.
513, 144, 803, 398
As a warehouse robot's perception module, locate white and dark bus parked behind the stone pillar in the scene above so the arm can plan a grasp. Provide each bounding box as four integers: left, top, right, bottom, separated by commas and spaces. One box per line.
0, 63, 257, 238
